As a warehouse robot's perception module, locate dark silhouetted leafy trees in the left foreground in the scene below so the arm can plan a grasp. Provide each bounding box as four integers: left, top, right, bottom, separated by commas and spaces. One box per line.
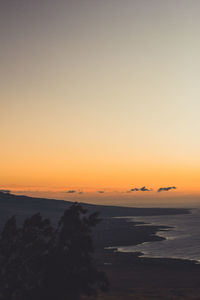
0, 203, 108, 300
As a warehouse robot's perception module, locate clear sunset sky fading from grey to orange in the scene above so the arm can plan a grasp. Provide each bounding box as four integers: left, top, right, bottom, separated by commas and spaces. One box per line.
0, 0, 200, 204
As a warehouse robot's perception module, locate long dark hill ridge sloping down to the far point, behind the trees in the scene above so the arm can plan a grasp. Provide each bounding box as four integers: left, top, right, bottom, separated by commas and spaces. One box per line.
0, 191, 190, 226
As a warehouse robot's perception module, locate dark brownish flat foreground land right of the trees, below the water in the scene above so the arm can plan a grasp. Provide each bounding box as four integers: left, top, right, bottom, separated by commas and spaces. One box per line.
95, 250, 200, 300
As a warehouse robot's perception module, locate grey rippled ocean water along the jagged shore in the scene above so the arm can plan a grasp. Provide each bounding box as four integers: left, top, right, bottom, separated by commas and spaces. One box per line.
118, 209, 200, 262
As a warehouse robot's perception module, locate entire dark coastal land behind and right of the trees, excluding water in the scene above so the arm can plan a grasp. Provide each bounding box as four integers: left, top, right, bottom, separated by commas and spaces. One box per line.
0, 192, 200, 300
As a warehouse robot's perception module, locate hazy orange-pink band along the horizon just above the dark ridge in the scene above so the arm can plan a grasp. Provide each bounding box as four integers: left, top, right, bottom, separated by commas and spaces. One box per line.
1, 189, 200, 209
